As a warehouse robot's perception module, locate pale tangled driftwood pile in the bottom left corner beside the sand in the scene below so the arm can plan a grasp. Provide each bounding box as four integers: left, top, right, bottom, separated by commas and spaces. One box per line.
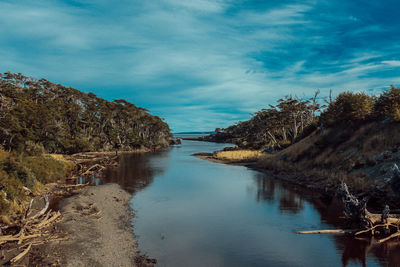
0, 184, 86, 264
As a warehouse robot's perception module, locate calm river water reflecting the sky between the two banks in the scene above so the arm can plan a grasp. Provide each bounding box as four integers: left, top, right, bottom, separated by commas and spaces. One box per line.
105, 141, 400, 266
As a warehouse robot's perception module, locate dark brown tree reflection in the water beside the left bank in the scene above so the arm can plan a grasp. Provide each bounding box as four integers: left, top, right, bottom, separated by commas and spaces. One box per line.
104, 152, 168, 193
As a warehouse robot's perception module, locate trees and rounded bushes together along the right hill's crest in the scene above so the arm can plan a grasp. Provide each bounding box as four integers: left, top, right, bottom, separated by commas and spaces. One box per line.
209, 86, 400, 149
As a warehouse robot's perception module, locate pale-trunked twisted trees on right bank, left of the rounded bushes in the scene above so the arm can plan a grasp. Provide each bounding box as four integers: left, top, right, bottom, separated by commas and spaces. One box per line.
212, 91, 321, 149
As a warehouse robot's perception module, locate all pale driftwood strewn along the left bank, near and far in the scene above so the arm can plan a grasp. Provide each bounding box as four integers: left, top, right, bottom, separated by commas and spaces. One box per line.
0, 152, 118, 265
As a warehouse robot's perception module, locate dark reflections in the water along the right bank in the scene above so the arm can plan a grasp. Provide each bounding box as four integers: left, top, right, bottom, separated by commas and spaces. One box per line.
254, 173, 400, 266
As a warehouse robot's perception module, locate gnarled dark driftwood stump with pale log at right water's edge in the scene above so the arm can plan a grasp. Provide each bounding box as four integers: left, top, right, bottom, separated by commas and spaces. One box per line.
298, 182, 400, 243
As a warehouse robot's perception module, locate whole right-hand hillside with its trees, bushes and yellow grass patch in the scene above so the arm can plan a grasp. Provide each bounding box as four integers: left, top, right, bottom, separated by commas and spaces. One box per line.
199, 86, 400, 207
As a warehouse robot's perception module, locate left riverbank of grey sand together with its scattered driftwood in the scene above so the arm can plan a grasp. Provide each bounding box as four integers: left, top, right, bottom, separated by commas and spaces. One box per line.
0, 150, 156, 266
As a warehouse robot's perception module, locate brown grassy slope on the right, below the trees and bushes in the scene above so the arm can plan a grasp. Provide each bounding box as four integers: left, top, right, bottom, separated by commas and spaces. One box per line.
255, 122, 400, 207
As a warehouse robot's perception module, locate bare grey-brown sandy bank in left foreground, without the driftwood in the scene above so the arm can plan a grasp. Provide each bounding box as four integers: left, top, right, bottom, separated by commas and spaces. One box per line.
30, 184, 144, 266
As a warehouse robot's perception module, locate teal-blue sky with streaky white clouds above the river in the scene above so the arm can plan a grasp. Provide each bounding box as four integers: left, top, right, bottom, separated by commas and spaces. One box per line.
0, 0, 400, 132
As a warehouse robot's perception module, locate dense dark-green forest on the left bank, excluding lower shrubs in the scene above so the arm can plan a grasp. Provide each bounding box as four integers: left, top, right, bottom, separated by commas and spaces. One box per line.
0, 72, 172, 153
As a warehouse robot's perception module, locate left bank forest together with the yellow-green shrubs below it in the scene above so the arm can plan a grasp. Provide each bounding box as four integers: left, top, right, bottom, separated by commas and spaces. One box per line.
0, 72, 173, 223
